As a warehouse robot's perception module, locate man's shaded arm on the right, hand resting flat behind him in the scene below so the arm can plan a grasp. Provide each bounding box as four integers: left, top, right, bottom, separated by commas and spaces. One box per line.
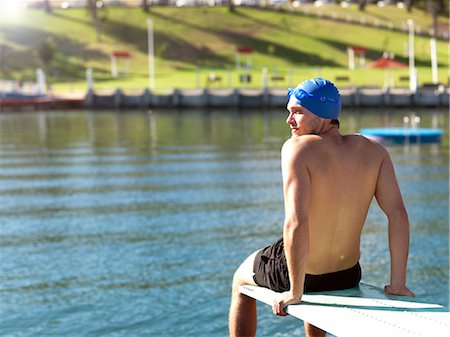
375, 149, 414, 296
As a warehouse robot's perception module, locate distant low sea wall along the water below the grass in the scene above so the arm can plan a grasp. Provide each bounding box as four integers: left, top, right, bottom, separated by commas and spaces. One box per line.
0, 85, 450, 111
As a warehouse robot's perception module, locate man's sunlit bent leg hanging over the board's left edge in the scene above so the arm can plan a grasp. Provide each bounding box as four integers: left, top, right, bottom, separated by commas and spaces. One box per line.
228, 251, 257, 337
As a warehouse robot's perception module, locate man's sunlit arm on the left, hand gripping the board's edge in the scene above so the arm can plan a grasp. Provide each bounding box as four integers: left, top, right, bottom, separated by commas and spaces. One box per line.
273, 139, 311, 316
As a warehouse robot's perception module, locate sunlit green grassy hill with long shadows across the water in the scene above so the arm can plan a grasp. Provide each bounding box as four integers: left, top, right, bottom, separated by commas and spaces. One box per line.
0, 6, 449, 90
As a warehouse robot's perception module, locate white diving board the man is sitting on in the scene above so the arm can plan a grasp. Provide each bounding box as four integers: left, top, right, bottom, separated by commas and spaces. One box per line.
239, 283, 450, 337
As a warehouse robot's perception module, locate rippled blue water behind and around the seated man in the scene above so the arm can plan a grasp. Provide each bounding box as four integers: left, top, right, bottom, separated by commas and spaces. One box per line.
0, 110, 449, 337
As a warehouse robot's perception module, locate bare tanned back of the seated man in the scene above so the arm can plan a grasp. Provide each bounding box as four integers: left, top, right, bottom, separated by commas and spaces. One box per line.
287, 133, 385, 275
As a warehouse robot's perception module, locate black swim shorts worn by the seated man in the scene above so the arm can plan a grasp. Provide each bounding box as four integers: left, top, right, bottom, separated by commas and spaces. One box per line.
253, 238, 361, 292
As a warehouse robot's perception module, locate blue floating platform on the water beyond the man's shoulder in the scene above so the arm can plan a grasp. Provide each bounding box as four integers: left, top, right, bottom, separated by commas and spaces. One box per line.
359, 128, 443, 144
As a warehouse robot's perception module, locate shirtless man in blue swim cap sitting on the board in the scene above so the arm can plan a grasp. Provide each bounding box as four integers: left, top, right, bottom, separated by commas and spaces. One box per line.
229, 78, 414, 336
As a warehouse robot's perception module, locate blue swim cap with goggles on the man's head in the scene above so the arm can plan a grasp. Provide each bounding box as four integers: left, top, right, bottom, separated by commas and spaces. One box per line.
288, 78, 341, 119
